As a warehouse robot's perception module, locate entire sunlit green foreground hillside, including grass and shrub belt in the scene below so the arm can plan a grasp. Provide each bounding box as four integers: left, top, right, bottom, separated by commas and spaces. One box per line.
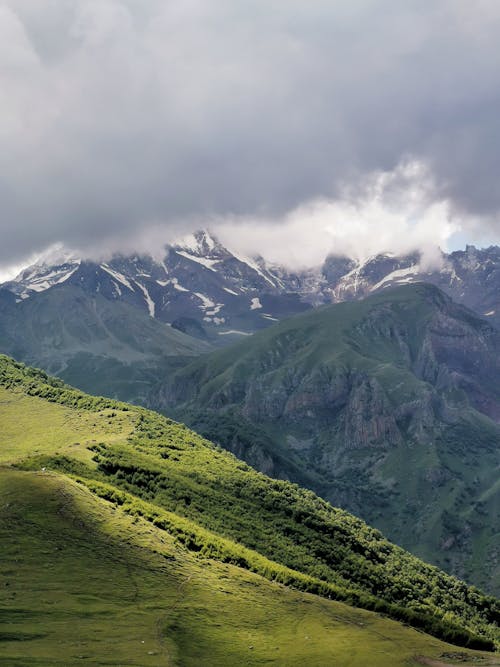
0, 356, 499, 667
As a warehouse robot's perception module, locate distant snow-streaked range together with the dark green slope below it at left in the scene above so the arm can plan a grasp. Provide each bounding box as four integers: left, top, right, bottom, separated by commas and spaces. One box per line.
0, 230, 500, 402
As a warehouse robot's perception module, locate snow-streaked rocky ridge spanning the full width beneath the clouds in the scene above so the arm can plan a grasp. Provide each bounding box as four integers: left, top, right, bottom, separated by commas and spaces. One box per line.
0, 230, 500, 346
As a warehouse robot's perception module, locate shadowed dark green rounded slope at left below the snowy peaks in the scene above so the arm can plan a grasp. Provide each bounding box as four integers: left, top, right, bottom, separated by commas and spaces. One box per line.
0, 285, 210, 401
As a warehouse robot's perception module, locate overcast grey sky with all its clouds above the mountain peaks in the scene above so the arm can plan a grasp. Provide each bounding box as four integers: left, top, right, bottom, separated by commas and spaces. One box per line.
0, 0, 500, 268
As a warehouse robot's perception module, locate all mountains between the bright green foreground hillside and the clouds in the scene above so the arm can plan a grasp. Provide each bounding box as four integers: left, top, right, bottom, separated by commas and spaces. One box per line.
0, 232, 500, 590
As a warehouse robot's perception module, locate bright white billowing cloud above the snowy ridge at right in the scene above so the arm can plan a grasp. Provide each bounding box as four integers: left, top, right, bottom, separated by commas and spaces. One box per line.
214, 161, 464, 268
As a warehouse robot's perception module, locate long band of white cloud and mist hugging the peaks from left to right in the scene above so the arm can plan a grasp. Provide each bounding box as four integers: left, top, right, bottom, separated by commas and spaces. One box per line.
0, 160, 495, 282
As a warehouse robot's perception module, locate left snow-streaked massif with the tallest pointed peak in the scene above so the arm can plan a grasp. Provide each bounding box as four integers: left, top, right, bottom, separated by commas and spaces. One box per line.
0, 231, 310, 344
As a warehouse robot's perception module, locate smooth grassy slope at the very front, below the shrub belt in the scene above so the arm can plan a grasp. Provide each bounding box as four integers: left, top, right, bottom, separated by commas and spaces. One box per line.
0, 468, 500, 667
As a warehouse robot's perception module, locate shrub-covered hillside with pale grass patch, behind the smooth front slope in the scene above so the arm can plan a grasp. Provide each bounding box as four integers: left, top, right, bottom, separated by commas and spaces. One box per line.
0, 357, 500, 664
